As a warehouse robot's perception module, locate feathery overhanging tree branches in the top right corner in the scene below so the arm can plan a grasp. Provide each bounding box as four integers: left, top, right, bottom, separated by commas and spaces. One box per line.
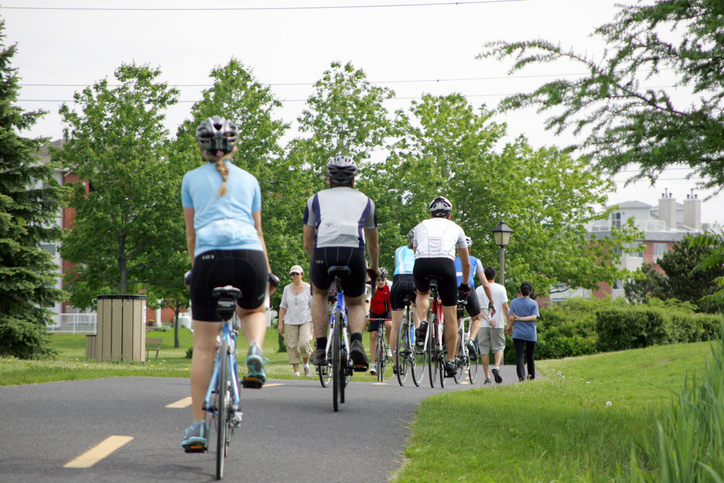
480, 0, 724, 190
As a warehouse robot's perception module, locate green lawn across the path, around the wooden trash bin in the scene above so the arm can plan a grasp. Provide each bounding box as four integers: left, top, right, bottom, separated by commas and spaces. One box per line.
0, 328, 384, 386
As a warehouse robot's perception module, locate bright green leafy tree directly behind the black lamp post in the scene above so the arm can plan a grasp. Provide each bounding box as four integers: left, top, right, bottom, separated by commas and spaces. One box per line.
378, 94, 636, 293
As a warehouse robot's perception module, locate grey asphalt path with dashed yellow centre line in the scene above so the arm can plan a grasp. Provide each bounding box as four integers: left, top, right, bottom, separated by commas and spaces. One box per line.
0, 366, 517, 483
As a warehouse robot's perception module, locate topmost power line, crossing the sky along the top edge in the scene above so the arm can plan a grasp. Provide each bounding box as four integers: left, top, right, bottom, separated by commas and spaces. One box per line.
0, 0, 528, 12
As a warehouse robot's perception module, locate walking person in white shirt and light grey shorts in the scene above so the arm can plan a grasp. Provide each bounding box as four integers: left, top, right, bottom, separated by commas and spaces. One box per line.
475, 267, 510, 384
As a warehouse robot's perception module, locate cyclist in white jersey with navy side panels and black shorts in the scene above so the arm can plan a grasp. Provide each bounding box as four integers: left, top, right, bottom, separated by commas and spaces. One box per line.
303, 156, 380, 371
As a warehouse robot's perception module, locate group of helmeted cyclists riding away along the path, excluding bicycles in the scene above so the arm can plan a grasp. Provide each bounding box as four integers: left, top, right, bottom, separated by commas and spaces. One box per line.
181, 116, 495, 448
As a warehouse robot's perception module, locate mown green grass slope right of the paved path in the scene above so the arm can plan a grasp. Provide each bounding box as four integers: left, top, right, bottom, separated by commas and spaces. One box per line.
393, 342, 711, 482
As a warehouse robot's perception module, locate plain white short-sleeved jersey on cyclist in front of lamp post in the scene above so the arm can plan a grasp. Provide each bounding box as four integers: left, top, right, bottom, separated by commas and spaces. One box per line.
413, 218, 468, 260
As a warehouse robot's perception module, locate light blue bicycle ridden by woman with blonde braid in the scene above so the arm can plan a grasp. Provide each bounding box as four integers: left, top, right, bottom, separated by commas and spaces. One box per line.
190, 285, 245, 480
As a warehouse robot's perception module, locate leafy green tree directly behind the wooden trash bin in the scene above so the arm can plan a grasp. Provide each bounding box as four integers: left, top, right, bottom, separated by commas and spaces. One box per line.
52, 64, 185, 307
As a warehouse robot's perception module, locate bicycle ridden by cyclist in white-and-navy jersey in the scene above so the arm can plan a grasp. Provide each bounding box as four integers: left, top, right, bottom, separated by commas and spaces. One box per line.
318, 266, 354, 412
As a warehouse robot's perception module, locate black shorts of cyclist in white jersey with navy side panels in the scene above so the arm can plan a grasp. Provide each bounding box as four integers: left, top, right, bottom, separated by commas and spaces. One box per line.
309, 247, 367, 297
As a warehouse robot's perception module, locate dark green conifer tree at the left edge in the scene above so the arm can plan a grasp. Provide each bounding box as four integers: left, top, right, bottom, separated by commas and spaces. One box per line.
0, 21, 63, 358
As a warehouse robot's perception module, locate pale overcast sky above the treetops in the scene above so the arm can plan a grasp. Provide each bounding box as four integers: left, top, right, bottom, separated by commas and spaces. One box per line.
5, 0, 724, 227
